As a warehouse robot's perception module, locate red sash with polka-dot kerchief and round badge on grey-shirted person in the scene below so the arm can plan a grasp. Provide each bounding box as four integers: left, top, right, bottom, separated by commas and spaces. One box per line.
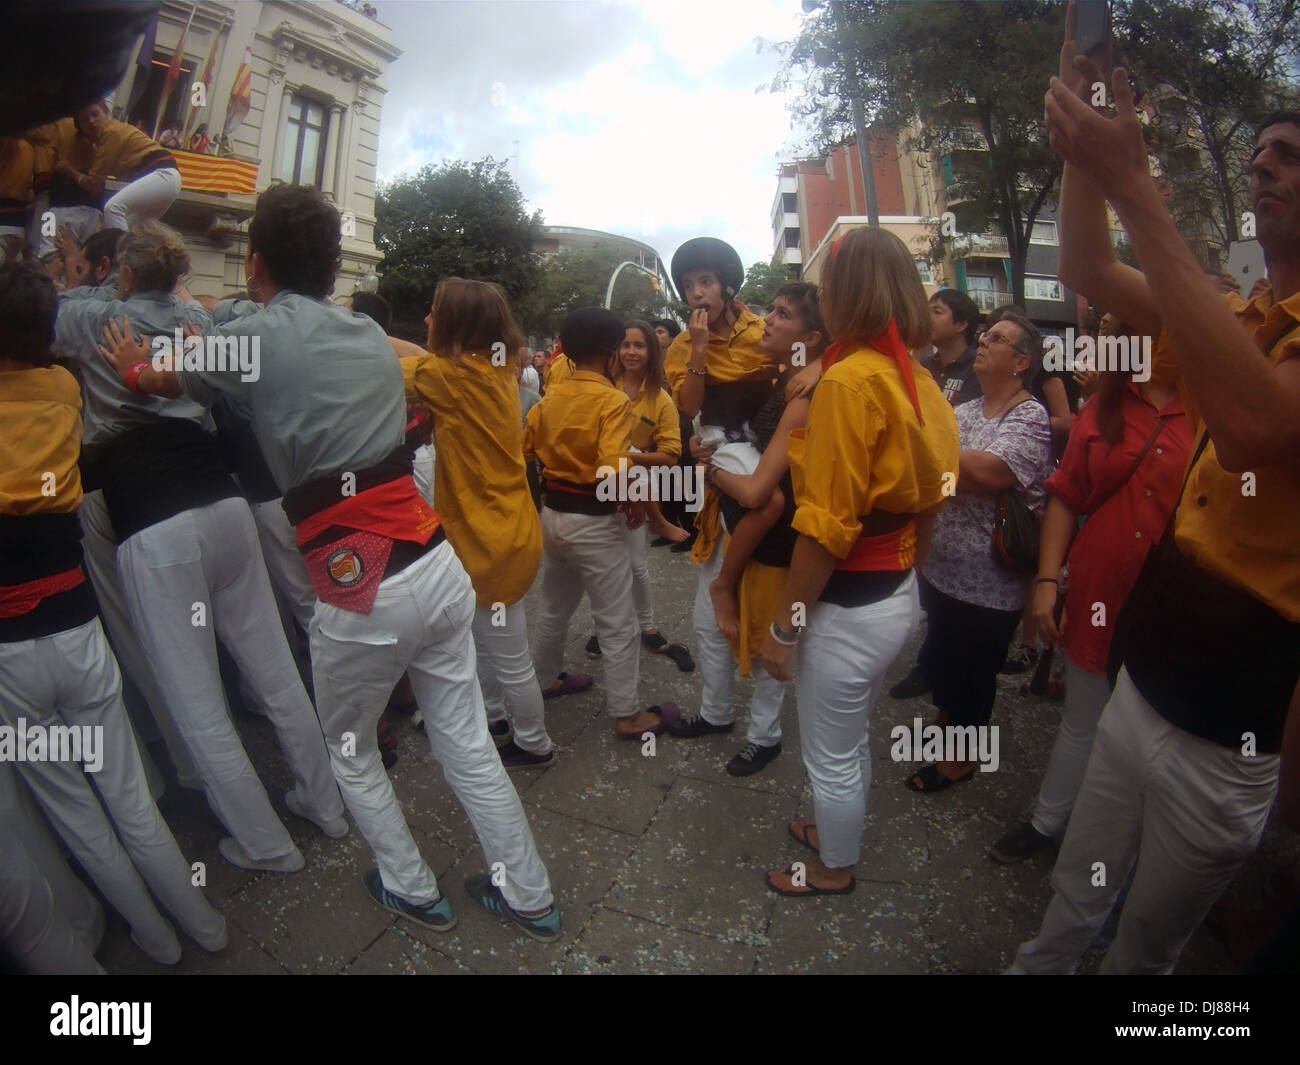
295, 473, 441, 614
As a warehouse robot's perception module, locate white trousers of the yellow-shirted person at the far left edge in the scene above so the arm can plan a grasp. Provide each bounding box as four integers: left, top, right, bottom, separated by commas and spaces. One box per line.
0, 618, 225, 954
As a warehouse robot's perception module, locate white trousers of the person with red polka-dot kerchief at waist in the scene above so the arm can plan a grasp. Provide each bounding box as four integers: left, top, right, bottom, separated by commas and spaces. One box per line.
312, 541, 554, 910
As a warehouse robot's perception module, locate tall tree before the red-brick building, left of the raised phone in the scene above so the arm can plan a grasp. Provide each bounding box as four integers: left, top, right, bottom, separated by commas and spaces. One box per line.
774, 0, 1065, 304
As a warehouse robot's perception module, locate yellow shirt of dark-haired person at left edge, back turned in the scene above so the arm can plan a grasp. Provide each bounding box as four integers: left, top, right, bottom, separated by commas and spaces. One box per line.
0, 367, 82, 518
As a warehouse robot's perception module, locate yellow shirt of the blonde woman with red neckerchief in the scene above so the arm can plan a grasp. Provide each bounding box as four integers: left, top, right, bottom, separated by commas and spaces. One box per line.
789, 347, 959, 558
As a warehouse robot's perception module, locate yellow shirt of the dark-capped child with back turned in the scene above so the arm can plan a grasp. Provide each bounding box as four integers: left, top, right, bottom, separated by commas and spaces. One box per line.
524, 369, 633, 485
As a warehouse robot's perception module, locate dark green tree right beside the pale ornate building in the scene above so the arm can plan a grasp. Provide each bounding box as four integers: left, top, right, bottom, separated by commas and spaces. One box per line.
374, 156, 542, 337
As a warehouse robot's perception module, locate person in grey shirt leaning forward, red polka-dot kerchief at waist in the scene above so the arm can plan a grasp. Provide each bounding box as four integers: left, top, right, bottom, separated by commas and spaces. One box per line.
105, 186, 560, 940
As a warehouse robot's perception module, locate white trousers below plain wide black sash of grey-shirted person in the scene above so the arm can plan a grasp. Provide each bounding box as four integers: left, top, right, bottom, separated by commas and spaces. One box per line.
117, 498, 343, 858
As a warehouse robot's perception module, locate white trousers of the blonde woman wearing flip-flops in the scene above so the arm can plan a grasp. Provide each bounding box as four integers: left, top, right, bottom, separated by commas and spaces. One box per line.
793, 573, 920, 869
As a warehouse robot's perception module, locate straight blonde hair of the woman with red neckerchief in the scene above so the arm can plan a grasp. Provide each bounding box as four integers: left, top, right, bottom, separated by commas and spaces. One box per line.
822, 226, 930, 351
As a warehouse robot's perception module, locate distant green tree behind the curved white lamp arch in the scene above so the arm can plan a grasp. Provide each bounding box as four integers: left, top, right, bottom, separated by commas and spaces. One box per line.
517, 247, 668, 337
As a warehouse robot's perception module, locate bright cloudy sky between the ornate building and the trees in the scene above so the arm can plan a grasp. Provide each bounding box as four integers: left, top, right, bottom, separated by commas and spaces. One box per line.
372, 0, 800, 279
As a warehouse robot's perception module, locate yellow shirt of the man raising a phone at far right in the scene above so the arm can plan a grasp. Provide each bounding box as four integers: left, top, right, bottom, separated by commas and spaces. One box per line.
1152, 289, 1300, 622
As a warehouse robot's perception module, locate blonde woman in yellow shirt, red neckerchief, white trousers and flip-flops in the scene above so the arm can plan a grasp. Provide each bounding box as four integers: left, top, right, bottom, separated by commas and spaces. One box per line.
761, 229, 958, 897
